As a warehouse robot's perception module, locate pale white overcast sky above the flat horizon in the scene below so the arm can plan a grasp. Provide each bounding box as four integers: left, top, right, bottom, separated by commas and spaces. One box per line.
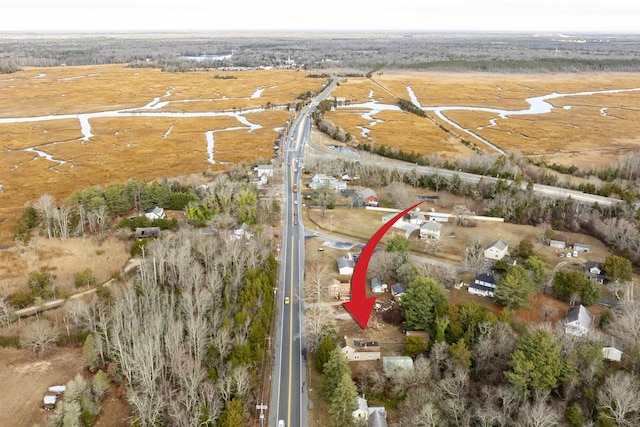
0, 0, 640, 33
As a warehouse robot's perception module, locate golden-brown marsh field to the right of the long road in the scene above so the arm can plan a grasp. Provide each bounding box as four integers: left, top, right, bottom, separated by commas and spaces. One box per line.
332, 72, 640, 167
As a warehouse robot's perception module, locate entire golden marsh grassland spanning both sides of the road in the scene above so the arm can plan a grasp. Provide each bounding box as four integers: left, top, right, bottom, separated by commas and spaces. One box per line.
0, 64, 640, 246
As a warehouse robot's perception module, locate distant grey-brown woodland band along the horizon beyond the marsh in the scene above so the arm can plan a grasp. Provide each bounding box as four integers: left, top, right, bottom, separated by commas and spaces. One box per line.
0, 32, 640, 72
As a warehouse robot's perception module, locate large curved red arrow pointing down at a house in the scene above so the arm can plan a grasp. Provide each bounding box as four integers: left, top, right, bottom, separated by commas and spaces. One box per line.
342, 202, 422, 329
